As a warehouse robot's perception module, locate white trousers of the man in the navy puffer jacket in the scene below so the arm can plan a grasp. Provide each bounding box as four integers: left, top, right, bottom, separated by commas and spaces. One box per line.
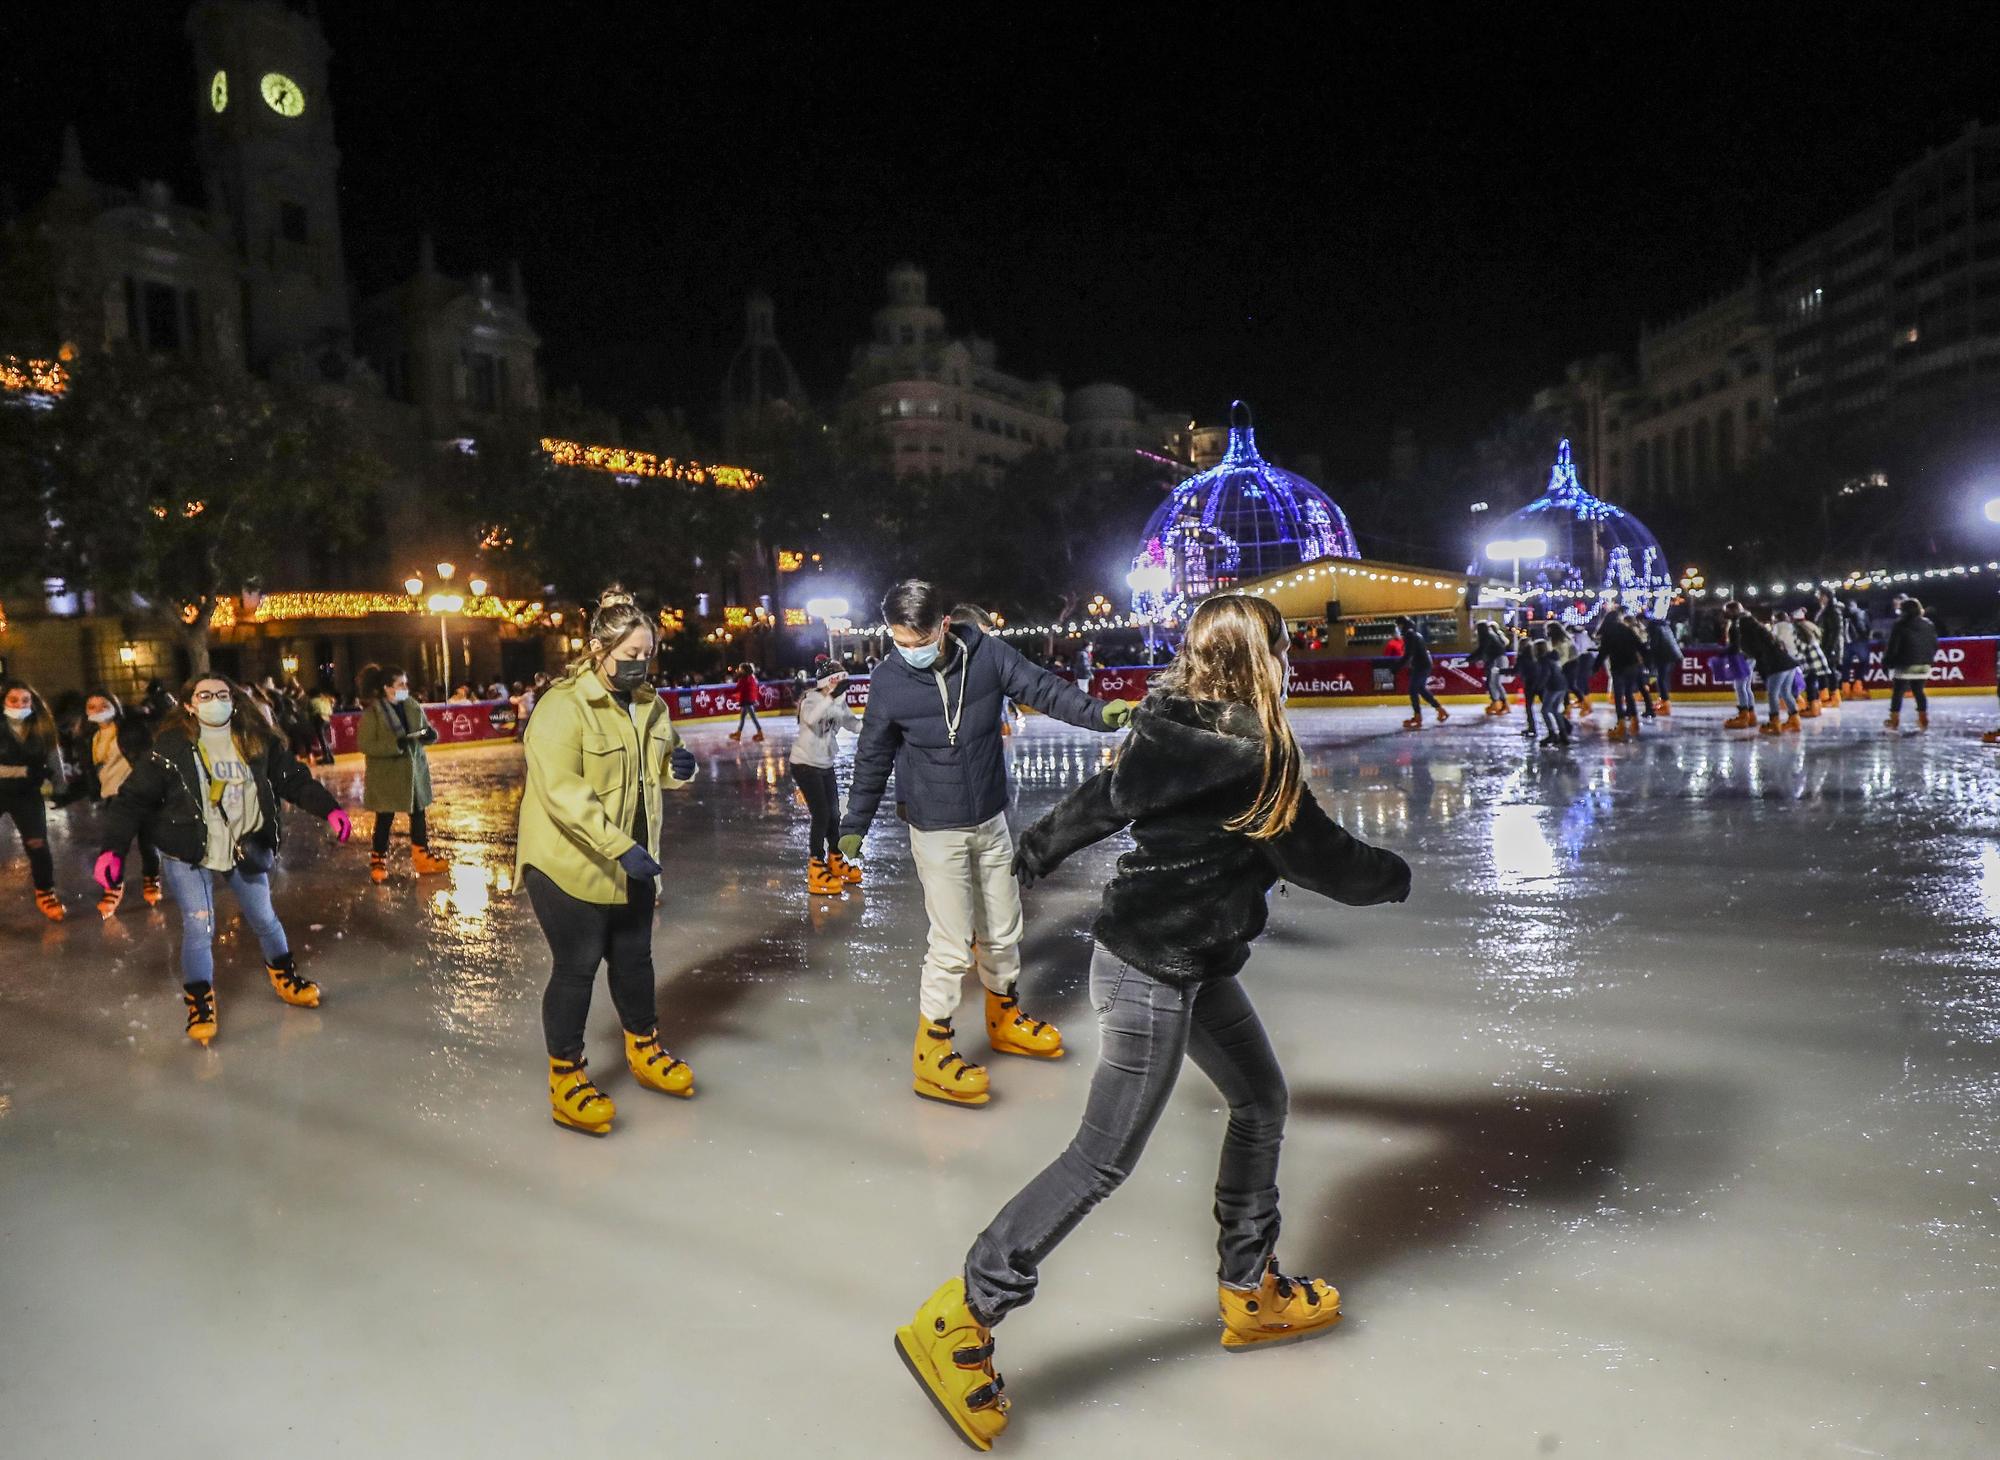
910, 814, 1020, 1020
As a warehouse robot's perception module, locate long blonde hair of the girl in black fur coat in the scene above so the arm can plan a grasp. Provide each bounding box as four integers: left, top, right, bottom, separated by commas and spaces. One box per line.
1160, 594, 1306, 842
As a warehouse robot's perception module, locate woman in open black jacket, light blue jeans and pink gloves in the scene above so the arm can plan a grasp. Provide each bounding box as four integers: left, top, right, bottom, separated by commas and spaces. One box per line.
96, 674, 354, 1046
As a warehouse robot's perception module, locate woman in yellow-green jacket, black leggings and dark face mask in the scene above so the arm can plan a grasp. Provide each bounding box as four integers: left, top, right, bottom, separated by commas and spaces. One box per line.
514, 588, 696, 1136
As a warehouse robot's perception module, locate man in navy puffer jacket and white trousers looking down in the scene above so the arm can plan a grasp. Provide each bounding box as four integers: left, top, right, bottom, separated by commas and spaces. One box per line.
840, 578, 1132, 1106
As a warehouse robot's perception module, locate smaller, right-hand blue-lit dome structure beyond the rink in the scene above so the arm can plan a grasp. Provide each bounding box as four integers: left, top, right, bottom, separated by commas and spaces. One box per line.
1468, 440, 1674, 618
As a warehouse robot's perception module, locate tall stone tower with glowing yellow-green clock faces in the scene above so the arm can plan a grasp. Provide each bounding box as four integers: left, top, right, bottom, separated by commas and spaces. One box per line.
188, 0, 352, 370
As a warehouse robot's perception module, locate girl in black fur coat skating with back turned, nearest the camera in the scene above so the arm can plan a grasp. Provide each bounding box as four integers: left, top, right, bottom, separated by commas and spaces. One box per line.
896, 594, 1410, 1450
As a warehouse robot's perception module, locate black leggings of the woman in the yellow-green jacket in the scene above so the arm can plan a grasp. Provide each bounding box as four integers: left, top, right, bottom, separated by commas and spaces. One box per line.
522, 866, 660, 1060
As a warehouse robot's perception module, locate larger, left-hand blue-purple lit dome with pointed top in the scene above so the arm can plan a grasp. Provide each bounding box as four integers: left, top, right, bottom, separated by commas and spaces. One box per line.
1126, 400, 1362, 618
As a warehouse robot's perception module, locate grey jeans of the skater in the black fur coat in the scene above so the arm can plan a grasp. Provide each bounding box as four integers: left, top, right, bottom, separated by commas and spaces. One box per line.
966, 946, 1286, 1324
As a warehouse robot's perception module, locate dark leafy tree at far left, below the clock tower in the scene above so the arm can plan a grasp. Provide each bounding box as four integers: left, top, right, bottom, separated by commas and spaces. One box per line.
0, 350, 388, 672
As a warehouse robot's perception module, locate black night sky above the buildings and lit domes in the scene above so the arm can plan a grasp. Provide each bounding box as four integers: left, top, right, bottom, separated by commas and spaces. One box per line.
0, 0, 2000, 474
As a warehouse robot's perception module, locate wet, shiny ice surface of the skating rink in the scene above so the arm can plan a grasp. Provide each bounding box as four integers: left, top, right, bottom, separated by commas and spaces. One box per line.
0, 700, 2000, 1460
